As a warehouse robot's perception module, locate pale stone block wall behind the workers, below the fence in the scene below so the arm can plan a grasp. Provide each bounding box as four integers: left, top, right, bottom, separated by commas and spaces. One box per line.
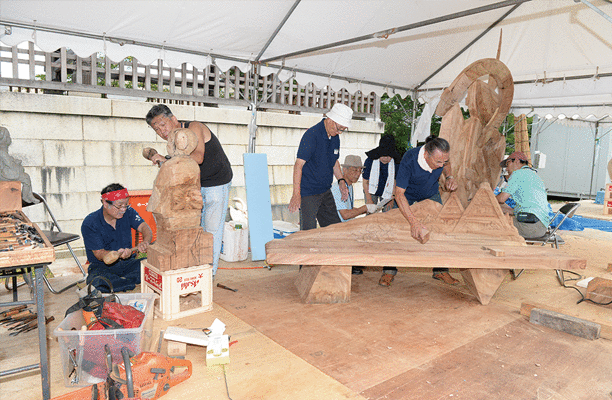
0, 92, 384, 257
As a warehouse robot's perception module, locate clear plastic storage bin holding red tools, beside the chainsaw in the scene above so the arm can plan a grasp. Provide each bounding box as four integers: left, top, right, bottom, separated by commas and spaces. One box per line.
53, 293, 157, 387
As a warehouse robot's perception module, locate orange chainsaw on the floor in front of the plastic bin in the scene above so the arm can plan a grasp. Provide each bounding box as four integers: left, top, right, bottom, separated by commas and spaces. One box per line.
53, 345, 192, 400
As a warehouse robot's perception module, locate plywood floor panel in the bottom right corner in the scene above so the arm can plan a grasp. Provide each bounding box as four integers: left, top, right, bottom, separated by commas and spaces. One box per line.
362, 319, 612, 400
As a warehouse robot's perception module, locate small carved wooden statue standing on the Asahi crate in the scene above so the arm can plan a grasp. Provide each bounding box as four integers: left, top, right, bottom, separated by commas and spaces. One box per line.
147, 129, 212, 271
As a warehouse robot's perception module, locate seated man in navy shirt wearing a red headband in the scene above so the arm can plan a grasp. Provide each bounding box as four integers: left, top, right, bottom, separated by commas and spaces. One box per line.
81, 183, 153, 293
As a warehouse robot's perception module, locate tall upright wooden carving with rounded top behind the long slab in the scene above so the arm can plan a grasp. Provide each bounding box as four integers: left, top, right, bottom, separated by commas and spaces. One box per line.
436, 58, 514, 207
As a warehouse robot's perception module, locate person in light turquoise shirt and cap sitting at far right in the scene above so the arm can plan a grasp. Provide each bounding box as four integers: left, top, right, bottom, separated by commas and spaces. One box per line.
497, 151, 550, 238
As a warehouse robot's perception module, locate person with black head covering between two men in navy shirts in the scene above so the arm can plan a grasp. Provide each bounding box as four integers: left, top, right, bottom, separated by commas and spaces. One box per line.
363, 135, 401, 209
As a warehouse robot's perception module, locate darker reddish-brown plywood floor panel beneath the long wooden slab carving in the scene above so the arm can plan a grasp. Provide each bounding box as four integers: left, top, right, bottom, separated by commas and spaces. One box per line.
214, 271, 521, 392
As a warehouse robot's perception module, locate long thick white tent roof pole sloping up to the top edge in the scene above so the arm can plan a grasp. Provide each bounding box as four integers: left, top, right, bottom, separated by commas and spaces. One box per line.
261, 0, 531, 63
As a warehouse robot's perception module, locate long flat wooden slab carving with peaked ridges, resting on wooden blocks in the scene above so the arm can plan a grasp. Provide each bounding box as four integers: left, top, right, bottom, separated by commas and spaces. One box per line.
266, 182, 586, 304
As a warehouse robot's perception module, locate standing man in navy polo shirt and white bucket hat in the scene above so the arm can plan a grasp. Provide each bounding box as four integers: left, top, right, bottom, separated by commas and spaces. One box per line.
289, 103, 353, 230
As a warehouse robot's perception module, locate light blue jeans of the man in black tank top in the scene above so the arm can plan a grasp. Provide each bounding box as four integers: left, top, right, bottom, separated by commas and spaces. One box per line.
200, 182, 232, 277
